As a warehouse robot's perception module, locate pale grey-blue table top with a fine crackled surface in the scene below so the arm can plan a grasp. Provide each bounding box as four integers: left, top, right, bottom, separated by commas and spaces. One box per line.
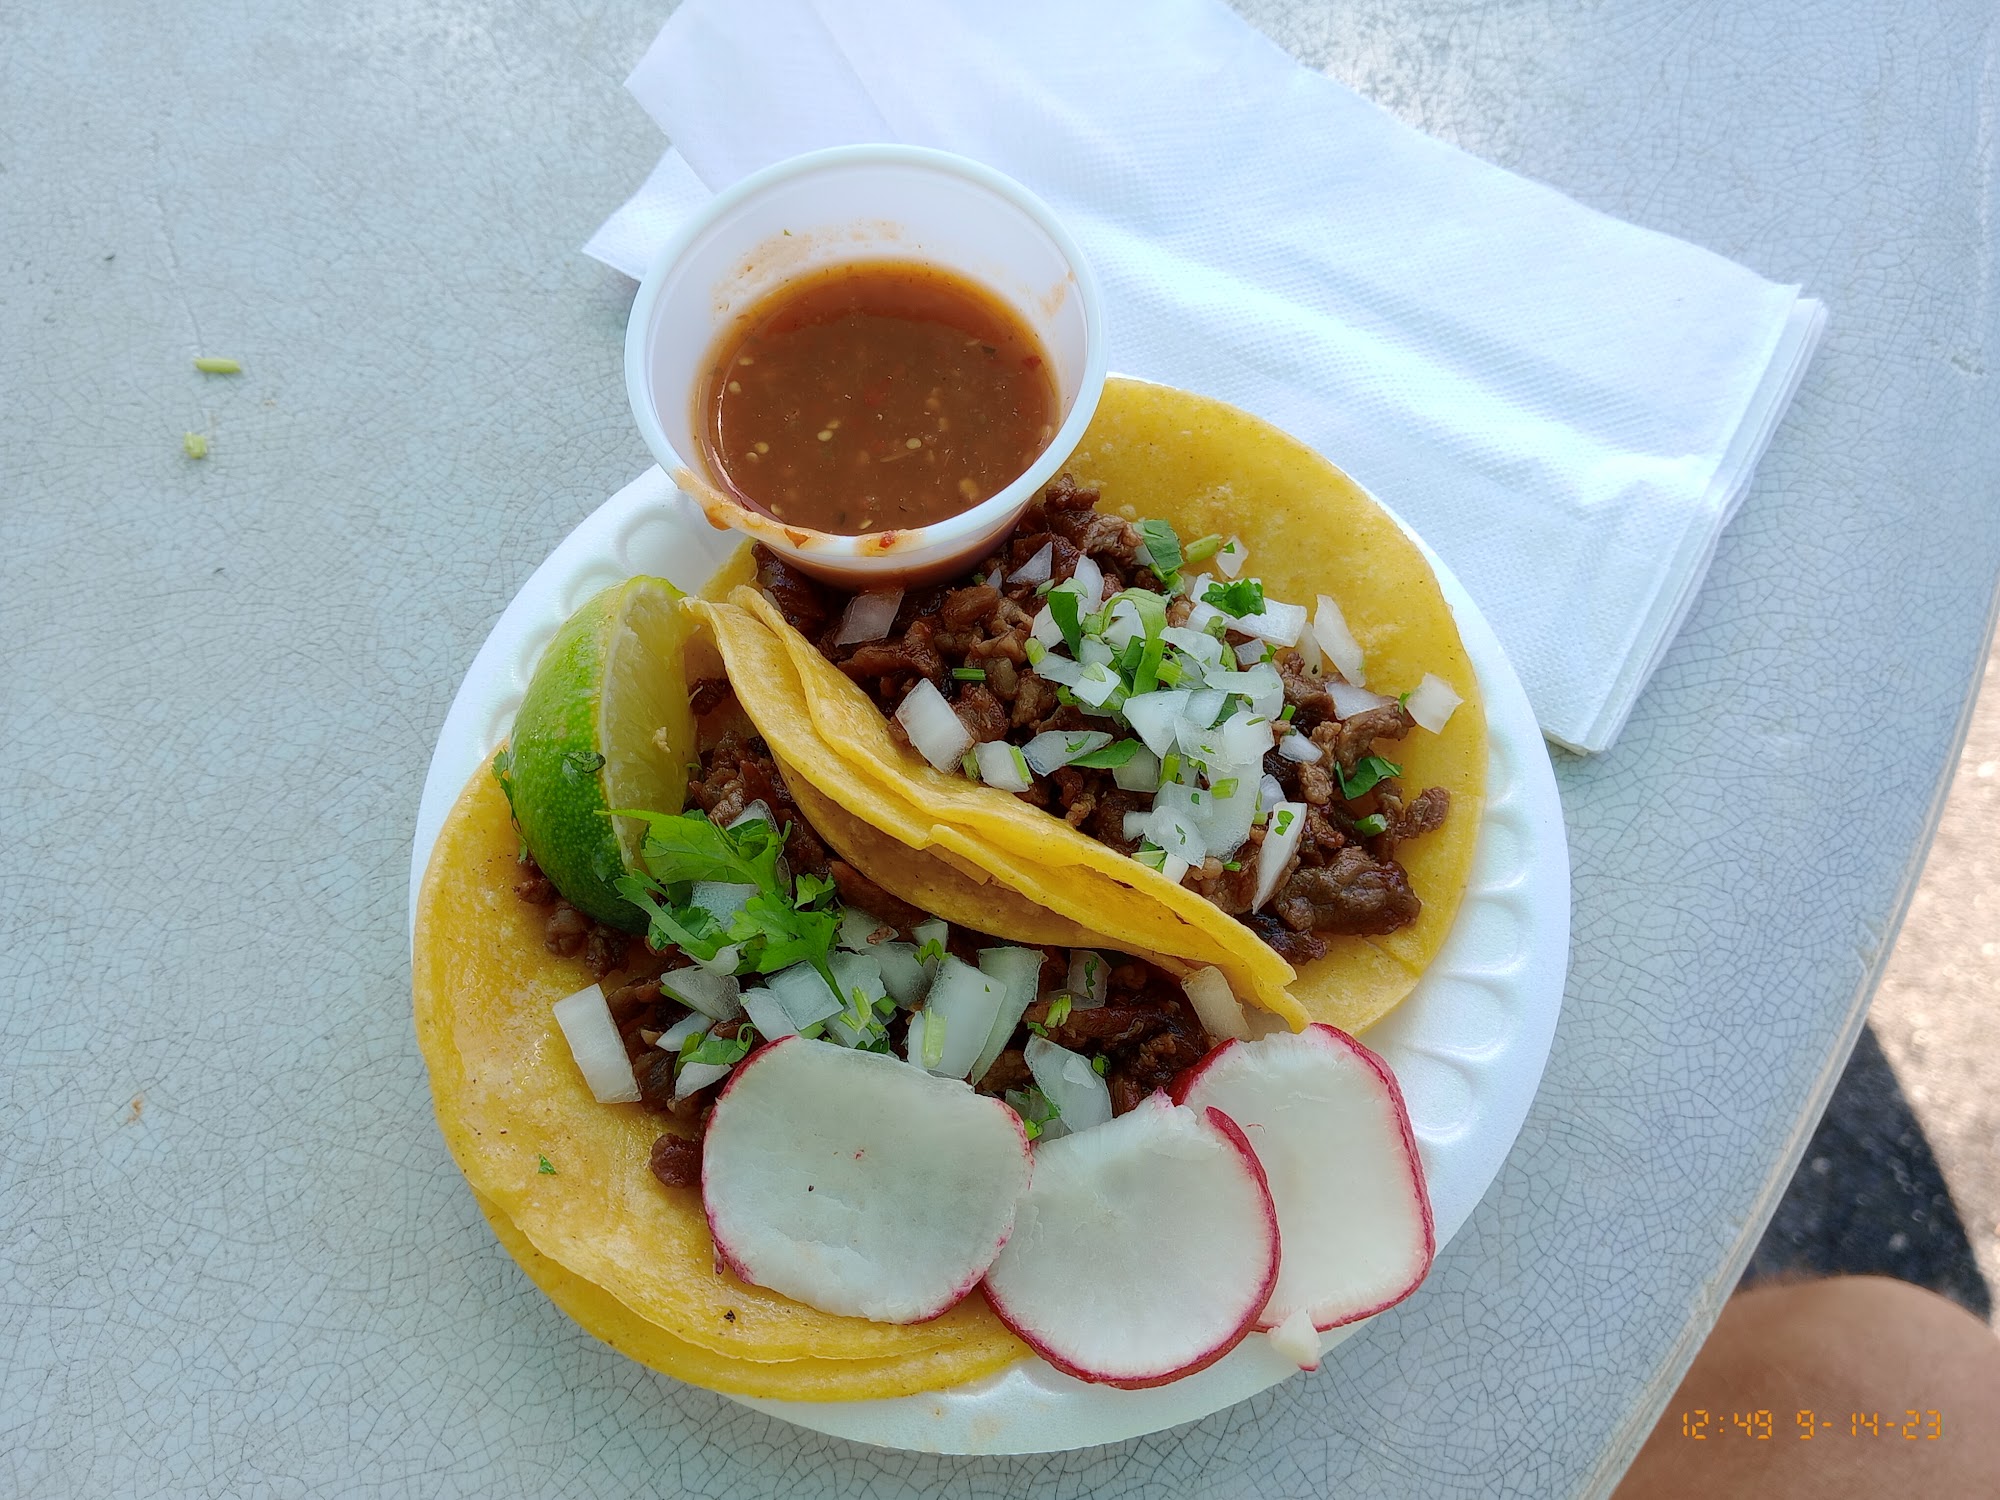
0, 0, 2000, 1500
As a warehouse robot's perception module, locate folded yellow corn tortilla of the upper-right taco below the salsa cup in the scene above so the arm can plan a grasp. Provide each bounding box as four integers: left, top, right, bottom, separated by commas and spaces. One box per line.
744, 380, 1486, 1032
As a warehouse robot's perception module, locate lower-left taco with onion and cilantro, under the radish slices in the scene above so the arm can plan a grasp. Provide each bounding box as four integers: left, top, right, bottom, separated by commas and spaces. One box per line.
414, 576, 1240, 1400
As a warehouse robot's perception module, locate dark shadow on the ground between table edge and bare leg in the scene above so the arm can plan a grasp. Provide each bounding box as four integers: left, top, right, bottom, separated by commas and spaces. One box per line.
1742, 1028, 1992, 1318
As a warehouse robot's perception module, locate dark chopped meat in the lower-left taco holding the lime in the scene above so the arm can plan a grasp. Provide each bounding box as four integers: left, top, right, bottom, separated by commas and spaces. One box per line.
514, 732, 1214, 1188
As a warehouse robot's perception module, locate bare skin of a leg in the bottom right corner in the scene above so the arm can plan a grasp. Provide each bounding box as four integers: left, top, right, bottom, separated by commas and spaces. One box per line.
1612, 1276, 2000, 1500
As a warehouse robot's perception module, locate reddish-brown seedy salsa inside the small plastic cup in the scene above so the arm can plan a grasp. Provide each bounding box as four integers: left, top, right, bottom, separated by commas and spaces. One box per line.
694, 260, 1056, 536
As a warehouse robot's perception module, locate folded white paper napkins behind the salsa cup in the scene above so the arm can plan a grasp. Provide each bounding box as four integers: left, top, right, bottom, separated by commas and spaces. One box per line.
586, 0, 1824, 750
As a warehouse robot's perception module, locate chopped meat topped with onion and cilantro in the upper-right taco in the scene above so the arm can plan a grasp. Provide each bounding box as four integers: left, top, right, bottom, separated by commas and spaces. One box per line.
756, 474, 1450, 964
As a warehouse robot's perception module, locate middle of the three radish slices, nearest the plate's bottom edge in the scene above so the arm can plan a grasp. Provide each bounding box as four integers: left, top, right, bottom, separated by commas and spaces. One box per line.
984, 1094, 1278, 1388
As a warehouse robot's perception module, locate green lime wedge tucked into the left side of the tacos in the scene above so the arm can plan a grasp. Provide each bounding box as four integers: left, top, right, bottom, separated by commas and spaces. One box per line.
504, 578, 696, 932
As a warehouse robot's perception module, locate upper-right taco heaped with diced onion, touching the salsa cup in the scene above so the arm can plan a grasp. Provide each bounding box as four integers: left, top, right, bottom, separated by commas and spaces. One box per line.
728, 380, 1486, 1032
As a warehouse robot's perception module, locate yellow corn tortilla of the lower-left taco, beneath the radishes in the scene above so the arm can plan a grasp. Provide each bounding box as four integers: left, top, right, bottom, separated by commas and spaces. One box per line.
414, 768, 1026, 1400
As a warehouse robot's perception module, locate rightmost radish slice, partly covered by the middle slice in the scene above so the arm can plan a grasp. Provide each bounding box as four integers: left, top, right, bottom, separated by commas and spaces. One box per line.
1174, 1024, 1436, 1330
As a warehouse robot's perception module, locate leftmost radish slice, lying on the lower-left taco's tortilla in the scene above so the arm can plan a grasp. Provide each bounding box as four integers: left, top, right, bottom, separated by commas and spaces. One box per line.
702, 1036, 1030, 1322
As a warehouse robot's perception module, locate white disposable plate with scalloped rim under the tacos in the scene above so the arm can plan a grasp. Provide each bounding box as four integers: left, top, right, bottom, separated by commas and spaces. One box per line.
410, 468, 1570, 1454
